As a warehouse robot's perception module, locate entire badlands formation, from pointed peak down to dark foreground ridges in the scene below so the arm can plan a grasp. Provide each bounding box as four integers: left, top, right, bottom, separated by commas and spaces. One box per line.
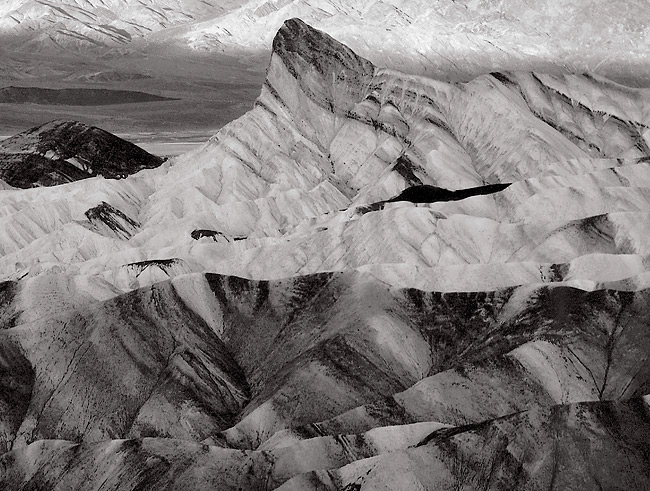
0, 19, 650, 491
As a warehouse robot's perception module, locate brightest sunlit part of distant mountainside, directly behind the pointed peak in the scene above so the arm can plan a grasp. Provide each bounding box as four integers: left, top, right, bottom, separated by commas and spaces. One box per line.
175, 0, 650, 84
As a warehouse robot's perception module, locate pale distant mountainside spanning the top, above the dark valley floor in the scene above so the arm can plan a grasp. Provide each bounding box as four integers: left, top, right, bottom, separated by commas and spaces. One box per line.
0, 0, 650, 84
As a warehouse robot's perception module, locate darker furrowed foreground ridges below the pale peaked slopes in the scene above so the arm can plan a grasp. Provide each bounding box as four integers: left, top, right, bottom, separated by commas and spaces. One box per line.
1, 273, 650, 489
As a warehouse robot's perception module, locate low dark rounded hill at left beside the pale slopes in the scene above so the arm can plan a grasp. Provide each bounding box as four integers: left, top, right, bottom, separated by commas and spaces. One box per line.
0, 121, 163, 188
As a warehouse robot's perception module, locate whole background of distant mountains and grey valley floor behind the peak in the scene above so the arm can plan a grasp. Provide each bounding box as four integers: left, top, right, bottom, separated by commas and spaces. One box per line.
0, 0, 650, 138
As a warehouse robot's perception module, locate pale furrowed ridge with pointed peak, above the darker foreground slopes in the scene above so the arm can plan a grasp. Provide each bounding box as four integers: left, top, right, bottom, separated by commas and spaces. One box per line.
0, 20, 649, 290
